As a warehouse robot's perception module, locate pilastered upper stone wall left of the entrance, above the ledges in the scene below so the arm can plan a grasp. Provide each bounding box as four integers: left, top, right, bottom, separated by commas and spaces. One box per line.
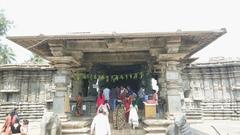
0, 65, 55, 103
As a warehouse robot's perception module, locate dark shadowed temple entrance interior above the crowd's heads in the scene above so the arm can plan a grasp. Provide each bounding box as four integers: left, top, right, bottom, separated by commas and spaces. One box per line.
78, 64, 152, 97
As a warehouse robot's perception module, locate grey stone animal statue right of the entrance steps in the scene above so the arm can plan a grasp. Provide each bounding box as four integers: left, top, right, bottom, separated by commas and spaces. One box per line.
167, 114, 193, 135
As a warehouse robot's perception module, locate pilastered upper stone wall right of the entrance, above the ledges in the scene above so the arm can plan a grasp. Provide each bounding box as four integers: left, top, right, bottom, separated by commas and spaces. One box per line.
182, 61, 240, 102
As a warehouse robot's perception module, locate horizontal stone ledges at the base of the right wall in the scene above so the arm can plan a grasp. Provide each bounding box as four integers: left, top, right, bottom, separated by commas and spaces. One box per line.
201, 102, 240, 120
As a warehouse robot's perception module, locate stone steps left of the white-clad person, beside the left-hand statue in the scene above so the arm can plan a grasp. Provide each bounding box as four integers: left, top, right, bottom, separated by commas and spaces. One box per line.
61, 117, 92, 135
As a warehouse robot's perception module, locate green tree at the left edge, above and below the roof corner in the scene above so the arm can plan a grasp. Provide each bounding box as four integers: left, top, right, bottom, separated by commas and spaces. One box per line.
0, 10, 15, 64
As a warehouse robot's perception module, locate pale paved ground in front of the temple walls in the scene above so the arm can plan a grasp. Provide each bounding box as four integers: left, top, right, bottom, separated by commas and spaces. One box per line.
0, 120, 240, 135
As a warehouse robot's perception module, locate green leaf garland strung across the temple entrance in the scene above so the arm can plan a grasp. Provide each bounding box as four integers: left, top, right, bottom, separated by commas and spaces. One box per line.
72, 72, 144, 82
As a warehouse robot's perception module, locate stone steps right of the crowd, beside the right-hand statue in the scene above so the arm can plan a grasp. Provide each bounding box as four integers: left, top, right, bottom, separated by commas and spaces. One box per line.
143, 119, 172, 135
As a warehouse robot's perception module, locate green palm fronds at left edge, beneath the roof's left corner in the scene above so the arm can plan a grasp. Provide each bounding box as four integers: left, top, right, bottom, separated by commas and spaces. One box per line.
0, 44, 15, 64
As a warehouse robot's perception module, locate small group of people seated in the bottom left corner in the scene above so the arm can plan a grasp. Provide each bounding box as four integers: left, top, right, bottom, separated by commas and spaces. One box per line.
1, 108, 29, 135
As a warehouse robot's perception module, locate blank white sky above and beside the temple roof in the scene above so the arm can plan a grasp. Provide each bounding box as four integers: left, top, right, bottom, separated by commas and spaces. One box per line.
0, 0, 240, 63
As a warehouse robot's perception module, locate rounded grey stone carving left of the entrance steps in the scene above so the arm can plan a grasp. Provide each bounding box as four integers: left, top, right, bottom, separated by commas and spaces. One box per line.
40, 112, 62, 135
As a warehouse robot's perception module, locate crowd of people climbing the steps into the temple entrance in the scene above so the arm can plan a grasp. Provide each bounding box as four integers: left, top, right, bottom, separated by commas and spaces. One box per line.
91, 86, 149, 135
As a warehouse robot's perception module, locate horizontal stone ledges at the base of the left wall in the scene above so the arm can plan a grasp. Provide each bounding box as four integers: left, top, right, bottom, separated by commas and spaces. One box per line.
0, 102, 45, 122
